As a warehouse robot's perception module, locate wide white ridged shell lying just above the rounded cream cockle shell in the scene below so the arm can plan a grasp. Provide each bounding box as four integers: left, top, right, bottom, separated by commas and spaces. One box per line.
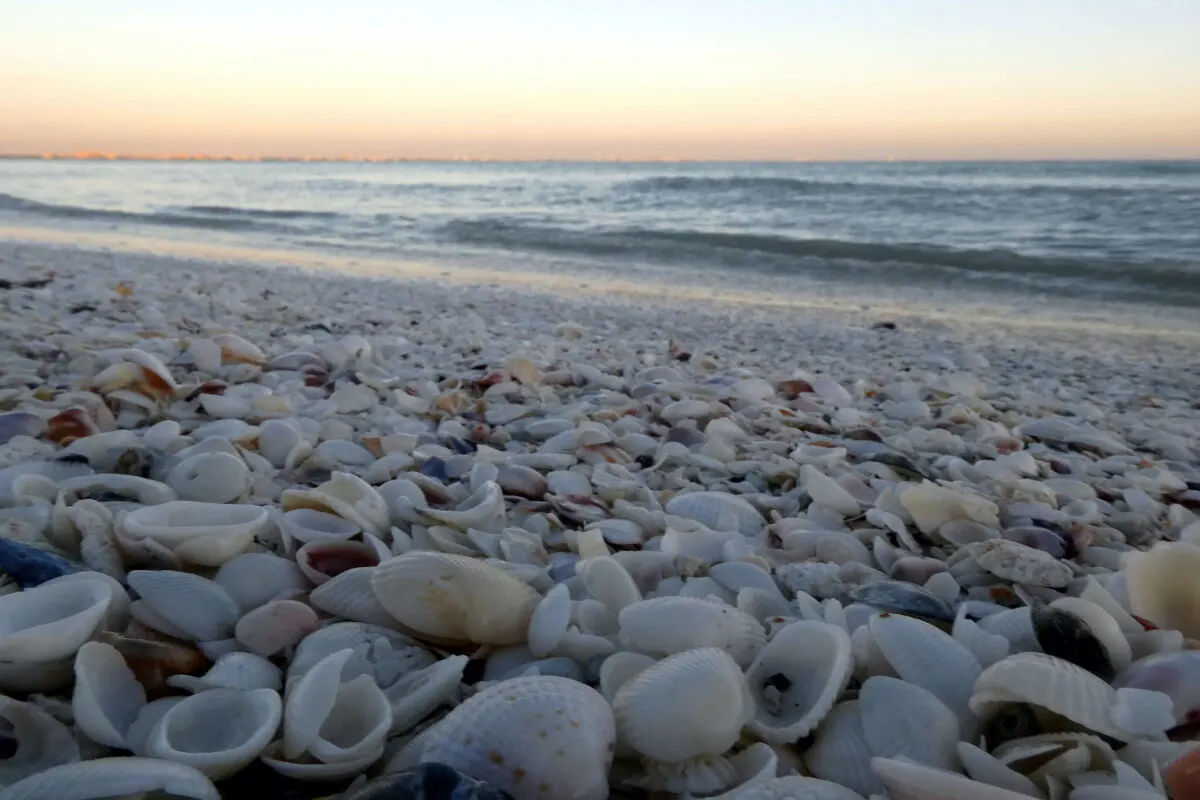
618, 597, 767, 667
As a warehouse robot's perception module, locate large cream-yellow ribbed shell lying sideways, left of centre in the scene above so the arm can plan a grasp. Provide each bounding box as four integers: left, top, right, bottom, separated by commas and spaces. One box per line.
371, 551, 541, 644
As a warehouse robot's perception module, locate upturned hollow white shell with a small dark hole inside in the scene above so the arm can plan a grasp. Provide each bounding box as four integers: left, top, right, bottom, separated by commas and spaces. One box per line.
745, 621, 853, 744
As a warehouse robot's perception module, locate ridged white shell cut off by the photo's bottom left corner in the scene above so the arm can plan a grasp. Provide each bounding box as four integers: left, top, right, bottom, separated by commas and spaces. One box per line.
0, 758, 221, 800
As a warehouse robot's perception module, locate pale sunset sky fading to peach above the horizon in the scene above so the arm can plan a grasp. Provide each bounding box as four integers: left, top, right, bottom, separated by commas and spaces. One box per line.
0, 0, 1200, 160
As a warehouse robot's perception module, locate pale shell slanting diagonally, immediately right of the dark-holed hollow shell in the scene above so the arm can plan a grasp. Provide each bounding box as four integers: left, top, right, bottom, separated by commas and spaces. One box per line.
868, 614, 983, 738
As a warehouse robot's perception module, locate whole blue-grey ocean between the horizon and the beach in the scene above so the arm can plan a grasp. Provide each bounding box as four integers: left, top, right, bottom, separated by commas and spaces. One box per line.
0, 160, 1200, 306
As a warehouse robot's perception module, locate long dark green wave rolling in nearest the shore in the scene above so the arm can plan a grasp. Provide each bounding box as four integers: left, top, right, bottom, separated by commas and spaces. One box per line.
443, 217, 1200, 294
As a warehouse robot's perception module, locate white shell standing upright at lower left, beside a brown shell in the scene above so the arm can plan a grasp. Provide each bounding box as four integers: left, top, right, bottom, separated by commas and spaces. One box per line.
71, 642, 146, 748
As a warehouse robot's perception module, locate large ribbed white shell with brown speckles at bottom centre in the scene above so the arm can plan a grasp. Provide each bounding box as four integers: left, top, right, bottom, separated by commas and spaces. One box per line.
420, 675, 614, 800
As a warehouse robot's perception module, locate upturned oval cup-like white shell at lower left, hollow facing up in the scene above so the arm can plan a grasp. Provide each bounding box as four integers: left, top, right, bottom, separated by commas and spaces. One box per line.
144, 688, 283, 781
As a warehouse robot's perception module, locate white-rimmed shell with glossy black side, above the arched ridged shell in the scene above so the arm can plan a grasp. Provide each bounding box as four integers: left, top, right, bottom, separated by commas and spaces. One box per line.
1030, 597, 1133, 681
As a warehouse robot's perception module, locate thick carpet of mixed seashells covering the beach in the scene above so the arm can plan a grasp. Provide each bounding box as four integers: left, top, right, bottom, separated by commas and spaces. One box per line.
0, 247, 1200, 800
